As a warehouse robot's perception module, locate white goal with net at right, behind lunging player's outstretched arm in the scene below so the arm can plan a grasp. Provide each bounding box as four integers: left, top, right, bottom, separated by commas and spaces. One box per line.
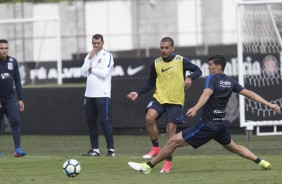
236, 0, 282, 135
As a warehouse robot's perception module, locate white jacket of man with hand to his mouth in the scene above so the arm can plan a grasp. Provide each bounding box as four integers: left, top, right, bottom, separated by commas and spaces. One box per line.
80, 49, 114, 98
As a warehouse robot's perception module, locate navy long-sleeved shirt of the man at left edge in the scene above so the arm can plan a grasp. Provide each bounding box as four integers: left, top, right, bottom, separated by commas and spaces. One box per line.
0, 56, 23, 101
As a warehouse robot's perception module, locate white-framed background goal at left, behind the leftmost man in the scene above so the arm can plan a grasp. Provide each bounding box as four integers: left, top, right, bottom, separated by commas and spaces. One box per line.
0, 17, 62, 84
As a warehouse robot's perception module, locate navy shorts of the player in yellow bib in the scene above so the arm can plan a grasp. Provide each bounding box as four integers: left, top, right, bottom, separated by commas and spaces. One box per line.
146, 98, 184, 124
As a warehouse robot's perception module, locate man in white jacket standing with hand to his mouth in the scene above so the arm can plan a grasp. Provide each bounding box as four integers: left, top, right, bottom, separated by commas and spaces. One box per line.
81, 34, 115, 156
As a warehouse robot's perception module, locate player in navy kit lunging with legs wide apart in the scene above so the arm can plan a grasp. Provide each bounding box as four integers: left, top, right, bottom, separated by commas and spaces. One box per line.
128, 55, 281, 174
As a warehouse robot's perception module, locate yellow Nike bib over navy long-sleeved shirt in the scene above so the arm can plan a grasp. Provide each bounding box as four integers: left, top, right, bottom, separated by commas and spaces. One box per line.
137, 53, 202, 106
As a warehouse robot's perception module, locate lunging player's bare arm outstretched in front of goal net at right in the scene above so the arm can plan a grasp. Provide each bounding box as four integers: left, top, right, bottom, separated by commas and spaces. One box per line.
239, 89, 281, 113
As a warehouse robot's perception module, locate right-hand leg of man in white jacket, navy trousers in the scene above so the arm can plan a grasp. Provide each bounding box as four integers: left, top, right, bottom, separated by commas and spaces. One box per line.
96, 97, 115, 156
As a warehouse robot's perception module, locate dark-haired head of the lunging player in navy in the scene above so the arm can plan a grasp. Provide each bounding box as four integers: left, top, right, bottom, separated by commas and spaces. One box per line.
208, 55, 226, 74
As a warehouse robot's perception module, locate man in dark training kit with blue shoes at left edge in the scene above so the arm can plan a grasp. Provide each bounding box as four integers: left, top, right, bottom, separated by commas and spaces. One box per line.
0, 39, 26, 157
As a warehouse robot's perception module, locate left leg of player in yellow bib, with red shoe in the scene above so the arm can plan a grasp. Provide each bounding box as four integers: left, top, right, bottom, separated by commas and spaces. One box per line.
143, 99, 165, 159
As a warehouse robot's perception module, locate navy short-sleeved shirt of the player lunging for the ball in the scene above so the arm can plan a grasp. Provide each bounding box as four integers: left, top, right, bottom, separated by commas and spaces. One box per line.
202, 74, 244, 121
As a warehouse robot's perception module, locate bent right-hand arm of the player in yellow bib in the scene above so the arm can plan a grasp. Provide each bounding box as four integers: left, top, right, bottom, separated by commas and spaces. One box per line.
183, 57, 202, 89
